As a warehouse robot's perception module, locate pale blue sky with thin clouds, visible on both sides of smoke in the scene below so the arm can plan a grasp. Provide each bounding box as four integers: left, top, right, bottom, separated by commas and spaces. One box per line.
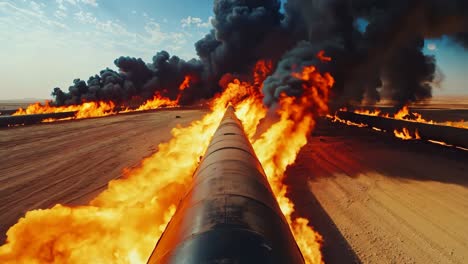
0, 0, 468, 100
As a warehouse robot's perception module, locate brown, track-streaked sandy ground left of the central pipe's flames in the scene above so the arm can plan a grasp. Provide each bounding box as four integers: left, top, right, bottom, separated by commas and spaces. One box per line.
0, 110, 204, 244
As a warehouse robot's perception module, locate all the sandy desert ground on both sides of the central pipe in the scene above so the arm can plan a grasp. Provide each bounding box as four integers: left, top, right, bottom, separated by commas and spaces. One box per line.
0, 100, 468, 263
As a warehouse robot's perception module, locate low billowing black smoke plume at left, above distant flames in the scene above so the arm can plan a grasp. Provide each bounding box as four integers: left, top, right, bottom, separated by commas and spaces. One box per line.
52, 51, 203, 105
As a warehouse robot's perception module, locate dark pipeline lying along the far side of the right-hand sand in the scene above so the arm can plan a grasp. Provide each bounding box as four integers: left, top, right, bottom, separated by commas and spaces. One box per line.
336, 111, 468, 148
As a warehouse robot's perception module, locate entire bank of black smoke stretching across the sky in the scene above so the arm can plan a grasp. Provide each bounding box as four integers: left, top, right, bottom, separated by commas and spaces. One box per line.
52, 0, 468, 106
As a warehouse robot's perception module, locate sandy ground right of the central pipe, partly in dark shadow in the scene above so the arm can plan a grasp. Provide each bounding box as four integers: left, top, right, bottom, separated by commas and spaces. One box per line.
287, 120, 468, 263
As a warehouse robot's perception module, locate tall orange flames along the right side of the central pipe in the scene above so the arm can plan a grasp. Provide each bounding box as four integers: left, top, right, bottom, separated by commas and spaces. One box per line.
240, 66, 334, 263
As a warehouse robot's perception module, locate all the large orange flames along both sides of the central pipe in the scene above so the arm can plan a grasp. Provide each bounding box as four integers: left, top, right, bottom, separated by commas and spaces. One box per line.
0, 56, 334, 264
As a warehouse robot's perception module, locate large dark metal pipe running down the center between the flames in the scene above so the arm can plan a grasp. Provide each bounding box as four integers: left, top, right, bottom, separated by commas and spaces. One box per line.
148, 106, 304, 264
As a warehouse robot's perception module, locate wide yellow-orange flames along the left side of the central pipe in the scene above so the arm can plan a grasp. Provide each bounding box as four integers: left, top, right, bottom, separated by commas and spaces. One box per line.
0, 81, 241, 263
